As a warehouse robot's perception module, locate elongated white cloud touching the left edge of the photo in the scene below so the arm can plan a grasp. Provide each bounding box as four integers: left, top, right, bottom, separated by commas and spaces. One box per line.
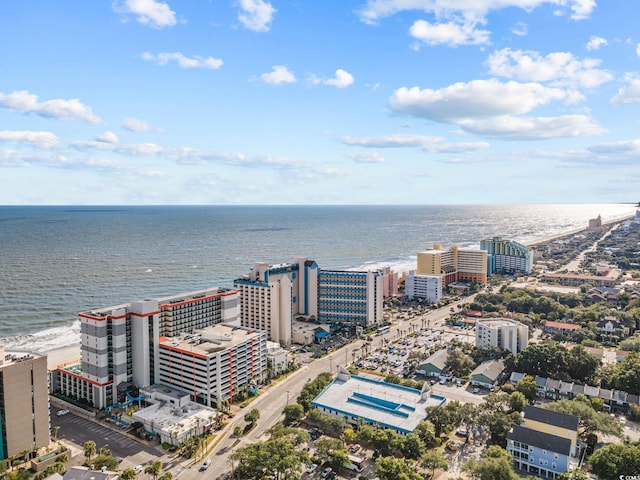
0, 90, 101, 125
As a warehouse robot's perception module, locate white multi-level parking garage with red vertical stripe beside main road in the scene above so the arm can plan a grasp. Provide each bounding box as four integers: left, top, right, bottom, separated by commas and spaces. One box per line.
158, 324, 267, 408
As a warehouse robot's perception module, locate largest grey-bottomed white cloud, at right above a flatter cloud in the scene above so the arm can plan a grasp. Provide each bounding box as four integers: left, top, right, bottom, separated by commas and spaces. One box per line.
390, 79, 567, 123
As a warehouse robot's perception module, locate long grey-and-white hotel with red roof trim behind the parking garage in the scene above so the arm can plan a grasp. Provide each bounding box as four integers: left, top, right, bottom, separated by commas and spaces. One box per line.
51, 288, 239, 408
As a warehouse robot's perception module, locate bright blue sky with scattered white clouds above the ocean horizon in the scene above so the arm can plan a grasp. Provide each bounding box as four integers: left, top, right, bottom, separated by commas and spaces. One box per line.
0, 0, 640, 205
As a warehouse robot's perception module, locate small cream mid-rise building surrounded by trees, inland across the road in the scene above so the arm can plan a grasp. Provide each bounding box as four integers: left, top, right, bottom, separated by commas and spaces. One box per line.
476, 318, 529, 354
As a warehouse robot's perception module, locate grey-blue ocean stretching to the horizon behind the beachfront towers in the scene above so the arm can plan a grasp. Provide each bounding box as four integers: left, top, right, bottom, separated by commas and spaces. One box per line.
0, 204, 635, 351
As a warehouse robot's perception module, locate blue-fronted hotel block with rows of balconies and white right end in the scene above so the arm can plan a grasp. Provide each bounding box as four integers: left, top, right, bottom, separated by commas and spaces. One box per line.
318, 269, 384, 328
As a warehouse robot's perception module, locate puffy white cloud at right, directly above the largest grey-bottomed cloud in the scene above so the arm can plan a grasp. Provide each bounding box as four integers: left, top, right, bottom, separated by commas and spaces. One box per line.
487, 48, 613, 88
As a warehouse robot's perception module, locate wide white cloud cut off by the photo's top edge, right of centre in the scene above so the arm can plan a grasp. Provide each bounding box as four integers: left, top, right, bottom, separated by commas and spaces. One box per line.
356, 0, 596, 24
